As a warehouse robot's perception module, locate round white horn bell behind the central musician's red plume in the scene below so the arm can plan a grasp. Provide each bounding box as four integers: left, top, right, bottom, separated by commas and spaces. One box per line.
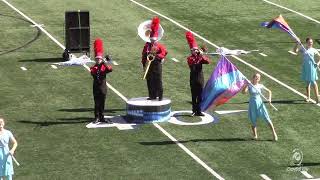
138, 20, 164, 42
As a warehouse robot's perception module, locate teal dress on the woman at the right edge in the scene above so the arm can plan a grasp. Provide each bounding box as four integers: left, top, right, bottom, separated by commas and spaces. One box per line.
300, 48, 319, 83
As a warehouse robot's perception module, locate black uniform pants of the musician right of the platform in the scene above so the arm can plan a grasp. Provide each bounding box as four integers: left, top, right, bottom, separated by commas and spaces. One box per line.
190, 82, 203, 113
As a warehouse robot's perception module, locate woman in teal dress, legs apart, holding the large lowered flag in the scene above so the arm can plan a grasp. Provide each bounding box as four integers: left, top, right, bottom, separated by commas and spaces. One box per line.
242, 73, 278, 141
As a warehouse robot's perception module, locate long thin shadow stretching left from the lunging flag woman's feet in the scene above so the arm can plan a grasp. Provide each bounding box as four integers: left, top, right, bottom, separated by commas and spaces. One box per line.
139, 138, 272, 146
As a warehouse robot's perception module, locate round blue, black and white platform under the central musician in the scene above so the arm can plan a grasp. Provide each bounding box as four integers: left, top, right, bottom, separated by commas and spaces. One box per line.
127, 97, 171, 123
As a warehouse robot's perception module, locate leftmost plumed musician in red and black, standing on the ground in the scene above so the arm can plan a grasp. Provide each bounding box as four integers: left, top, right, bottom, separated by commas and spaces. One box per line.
90, 38, 112, 123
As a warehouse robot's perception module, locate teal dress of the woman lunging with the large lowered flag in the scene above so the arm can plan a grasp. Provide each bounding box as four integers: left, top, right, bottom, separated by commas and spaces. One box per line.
248, 84, 271, 126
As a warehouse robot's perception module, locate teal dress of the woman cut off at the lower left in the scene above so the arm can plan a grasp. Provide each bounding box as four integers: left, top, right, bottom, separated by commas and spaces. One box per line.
0, 129, 13, 176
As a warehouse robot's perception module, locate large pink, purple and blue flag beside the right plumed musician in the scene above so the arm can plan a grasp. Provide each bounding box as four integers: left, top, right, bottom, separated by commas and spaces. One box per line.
200, 56, 247, 111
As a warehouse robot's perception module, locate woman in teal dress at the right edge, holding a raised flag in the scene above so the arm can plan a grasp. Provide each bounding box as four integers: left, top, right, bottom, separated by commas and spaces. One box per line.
293, 37, 320, 103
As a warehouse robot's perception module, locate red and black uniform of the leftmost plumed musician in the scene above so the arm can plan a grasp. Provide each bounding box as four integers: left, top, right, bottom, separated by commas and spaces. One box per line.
90, 63, 112, 121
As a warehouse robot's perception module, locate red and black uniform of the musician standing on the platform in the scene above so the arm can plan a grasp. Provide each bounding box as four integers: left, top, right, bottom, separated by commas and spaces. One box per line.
141, 42, 168, 100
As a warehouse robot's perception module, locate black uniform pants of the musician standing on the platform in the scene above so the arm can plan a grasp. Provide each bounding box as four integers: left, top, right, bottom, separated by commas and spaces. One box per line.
147, 62, 163, 99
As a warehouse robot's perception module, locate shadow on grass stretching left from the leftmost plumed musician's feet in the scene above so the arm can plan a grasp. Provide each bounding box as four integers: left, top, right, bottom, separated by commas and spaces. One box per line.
18, 117, 92, 127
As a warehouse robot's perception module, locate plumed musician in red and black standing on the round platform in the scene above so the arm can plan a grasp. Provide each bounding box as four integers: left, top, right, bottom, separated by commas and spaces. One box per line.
141, 17, 168, 101
